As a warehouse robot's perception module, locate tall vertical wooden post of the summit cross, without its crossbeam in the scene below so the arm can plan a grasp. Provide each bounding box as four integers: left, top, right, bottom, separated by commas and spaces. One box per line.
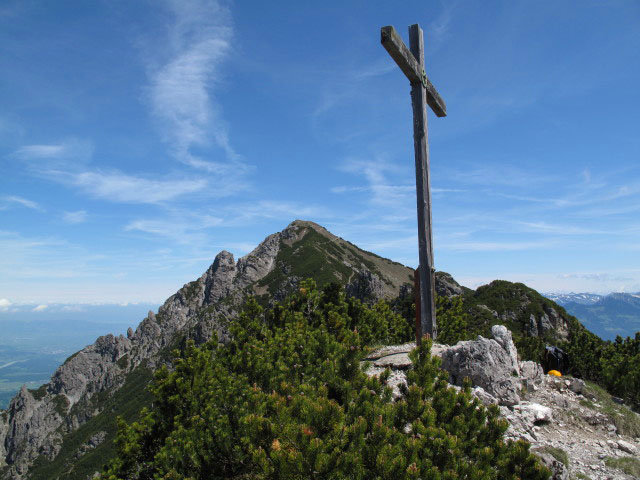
409, 24, 437, 340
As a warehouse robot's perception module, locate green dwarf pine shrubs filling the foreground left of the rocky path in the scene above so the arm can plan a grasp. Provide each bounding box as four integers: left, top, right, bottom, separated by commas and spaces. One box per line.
100, 281, 549, 480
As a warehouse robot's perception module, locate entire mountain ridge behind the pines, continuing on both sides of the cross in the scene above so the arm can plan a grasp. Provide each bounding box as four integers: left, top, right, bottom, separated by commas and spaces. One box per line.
0, 220, 596, 479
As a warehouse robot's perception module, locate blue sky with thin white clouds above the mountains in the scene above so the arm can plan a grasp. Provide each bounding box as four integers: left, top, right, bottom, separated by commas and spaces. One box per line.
0, 0, 640, 311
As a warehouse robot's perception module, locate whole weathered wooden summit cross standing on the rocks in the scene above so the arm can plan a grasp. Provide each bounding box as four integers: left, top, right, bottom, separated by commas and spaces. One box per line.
380, 24, 447, 344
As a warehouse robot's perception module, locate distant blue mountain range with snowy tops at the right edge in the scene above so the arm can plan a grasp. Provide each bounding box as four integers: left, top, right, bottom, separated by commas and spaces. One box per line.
544, 292, 640, 340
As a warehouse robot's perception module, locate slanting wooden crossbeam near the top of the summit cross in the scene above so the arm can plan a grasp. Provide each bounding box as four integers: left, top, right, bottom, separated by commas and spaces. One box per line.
380, 26, 447, 117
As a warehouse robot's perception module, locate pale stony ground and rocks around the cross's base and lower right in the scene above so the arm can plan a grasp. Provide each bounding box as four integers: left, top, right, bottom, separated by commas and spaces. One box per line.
366, 327, 640, 480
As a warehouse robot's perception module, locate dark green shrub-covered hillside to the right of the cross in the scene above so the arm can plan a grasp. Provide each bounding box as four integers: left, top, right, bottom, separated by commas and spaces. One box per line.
424, 280, 640, 410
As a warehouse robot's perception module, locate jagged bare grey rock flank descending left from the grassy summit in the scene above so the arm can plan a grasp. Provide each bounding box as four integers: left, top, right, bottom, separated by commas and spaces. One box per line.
0, 230, 279, 479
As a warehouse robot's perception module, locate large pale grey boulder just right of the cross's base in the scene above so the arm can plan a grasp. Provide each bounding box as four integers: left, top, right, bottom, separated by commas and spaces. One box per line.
442, 325, 520, 405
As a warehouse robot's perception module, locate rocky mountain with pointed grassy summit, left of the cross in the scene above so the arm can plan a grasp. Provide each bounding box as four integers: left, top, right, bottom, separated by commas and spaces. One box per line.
0, 220, 413, 480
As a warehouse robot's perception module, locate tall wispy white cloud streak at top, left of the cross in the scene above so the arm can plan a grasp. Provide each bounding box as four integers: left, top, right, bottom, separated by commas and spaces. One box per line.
148, 0, 249, 177
